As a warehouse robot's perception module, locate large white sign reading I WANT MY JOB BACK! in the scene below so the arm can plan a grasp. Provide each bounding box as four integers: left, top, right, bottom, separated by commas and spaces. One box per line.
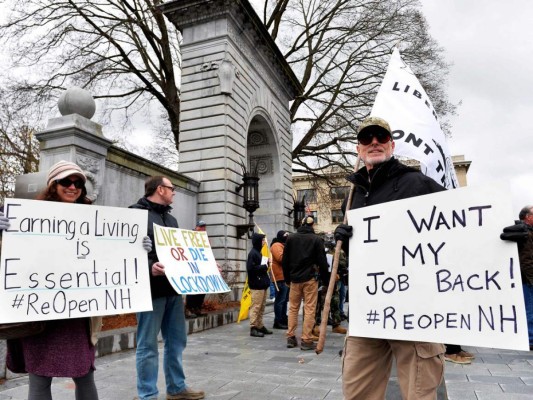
348, 184, 529, 350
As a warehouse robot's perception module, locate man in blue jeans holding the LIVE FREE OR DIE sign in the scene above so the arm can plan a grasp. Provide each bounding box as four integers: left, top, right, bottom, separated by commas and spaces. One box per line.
130, 176, 205, 400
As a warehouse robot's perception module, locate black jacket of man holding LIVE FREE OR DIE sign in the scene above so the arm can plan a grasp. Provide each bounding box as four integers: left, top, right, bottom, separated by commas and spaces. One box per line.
129, 197, 179, 299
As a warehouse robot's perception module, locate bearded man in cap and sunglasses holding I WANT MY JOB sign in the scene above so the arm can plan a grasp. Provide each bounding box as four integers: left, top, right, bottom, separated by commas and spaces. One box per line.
335, 117, 444, 400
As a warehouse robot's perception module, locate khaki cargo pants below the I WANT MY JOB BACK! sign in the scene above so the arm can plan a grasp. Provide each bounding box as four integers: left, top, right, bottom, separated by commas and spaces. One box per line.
342, 336, 444, 400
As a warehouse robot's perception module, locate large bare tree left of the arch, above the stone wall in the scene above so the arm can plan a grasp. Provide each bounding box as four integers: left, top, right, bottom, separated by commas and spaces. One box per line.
0, 0, 180, 150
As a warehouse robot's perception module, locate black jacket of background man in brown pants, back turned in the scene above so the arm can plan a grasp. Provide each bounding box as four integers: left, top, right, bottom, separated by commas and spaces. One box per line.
282, 225, 329, 285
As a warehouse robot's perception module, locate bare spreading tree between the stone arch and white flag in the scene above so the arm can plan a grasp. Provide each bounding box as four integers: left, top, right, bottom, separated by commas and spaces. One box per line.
263, 0, 455, 177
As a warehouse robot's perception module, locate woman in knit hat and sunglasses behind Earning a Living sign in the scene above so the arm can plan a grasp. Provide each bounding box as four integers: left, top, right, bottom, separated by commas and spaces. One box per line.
8, 161, 102, 400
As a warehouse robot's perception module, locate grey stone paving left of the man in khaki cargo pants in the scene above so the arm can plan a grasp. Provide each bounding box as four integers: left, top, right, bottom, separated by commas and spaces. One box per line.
0, 313, 344, 400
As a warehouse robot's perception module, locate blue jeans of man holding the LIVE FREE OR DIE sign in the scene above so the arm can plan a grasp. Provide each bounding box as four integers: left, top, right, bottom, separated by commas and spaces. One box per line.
136, 296, 187, 400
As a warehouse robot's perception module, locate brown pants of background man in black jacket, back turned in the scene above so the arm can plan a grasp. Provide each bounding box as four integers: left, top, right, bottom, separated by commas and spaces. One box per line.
287, 279, 318, 342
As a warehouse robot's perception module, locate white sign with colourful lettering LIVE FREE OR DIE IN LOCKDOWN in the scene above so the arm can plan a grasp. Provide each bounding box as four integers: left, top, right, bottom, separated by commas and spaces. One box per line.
154, 224, 231, 294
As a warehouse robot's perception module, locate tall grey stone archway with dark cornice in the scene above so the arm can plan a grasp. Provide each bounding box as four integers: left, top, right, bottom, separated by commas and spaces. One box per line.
160, 0, 303, 272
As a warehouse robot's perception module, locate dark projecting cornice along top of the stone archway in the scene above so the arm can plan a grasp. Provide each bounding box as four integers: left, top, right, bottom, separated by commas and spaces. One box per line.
159, 0, 303, 99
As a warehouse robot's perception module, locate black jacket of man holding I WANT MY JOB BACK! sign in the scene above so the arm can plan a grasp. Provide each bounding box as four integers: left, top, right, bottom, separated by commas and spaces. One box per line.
342, 157, 446, 254
